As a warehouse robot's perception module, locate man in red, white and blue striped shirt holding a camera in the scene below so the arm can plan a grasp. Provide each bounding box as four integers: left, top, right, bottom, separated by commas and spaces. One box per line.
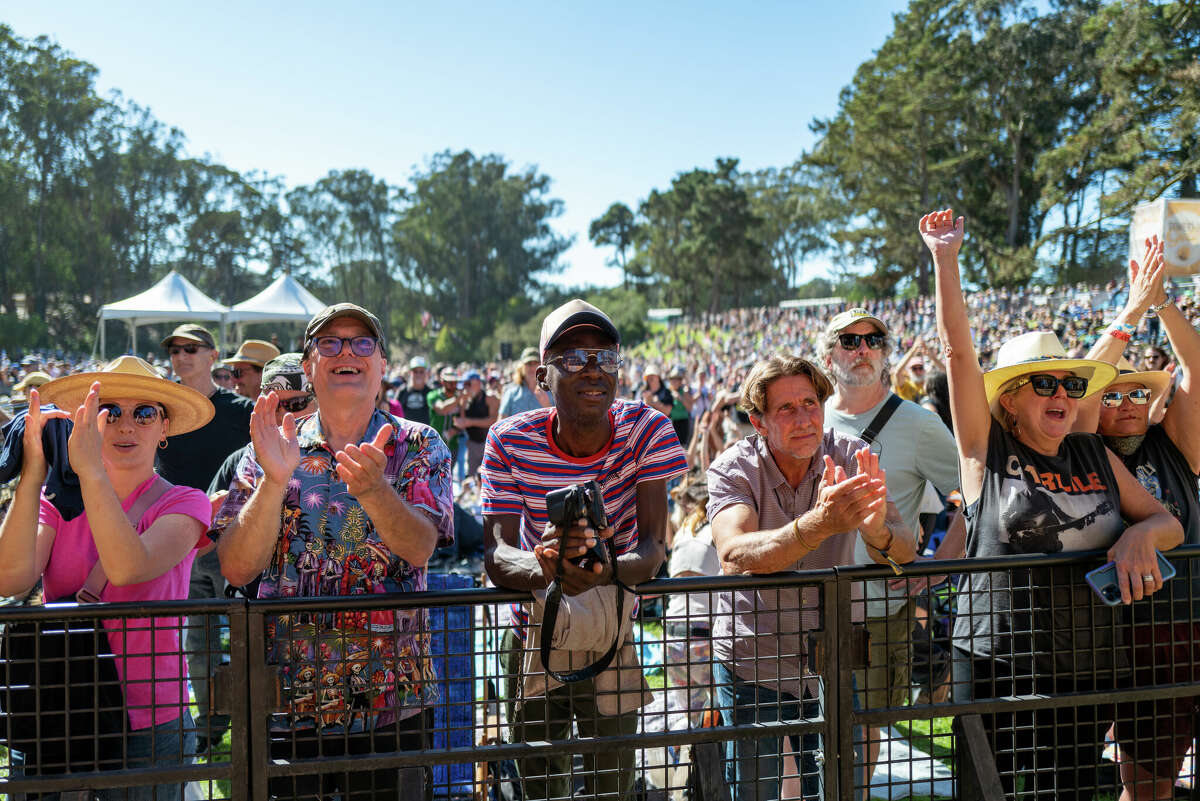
480, 300, 688, 800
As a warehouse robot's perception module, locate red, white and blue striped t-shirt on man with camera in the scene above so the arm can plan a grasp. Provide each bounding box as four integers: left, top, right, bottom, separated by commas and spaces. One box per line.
479, 401, 688, 633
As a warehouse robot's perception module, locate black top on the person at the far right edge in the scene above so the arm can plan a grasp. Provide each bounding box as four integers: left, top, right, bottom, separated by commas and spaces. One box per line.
1122, 424, 1200, 621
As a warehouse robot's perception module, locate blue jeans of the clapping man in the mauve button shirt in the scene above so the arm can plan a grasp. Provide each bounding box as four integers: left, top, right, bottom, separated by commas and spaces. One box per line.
713, 662, 863, 801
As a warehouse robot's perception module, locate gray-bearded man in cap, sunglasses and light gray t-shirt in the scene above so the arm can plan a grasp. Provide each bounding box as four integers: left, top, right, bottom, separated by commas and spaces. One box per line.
818, 308, 966, 776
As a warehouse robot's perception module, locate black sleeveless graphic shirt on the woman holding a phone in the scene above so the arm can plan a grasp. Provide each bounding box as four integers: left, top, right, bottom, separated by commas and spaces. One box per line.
954, 420, 1124, 674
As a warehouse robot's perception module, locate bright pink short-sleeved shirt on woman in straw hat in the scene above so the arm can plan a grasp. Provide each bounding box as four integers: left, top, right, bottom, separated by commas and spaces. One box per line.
38, 477, 212, 729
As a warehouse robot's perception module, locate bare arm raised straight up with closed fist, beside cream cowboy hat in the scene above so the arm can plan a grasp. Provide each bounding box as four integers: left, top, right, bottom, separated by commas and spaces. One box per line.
919, 209, 991, 505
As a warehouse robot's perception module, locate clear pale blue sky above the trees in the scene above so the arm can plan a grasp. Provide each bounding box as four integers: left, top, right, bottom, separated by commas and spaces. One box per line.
7, 0, 906, 284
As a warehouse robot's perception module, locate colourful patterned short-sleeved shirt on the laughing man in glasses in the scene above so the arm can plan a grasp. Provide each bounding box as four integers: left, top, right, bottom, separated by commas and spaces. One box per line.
212, 410, 454, 734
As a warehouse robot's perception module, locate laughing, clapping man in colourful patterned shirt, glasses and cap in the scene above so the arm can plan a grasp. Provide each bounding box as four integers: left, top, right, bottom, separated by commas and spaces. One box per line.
212, 303, 454, 799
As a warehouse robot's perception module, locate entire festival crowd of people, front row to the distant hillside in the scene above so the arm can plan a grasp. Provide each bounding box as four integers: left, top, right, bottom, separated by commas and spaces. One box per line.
0, 211, 1200, 801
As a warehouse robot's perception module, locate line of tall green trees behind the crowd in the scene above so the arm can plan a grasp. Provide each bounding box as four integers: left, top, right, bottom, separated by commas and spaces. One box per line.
0, 0, 1200, 359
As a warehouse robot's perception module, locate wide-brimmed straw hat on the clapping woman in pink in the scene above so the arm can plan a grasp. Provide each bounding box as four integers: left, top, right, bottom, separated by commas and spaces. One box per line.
38, 356, 215, 436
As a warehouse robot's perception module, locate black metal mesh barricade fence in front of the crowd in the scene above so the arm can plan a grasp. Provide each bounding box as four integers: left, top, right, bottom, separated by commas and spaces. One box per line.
0, 548, 1200, 801
